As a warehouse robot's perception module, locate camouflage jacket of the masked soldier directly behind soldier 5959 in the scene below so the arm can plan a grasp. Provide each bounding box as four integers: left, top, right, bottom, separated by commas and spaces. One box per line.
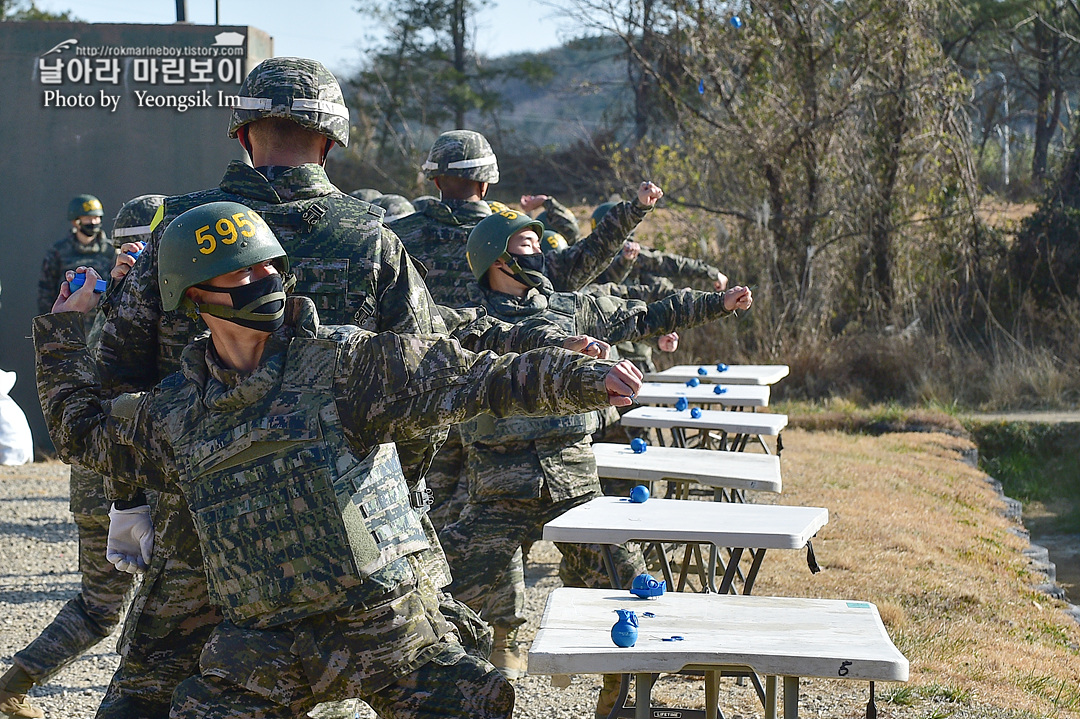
461, 276, 729, 502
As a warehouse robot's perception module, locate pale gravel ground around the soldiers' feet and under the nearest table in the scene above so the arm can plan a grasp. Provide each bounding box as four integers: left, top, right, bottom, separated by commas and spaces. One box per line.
0, 462, 1028, 719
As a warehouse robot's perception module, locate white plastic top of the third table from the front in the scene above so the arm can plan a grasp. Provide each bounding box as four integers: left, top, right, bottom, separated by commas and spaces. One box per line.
593, 443, 783, 492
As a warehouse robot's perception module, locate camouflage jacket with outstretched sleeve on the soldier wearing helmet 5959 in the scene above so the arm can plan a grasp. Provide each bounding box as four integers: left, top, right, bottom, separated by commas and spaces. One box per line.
33, 298, 611, 625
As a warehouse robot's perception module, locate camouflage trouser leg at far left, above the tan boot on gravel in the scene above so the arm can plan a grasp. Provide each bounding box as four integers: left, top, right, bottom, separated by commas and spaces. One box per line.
14, 507, 135, 684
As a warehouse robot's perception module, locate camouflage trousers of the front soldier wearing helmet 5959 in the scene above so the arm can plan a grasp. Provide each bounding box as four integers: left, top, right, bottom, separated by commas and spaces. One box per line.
171, 591, 514, 719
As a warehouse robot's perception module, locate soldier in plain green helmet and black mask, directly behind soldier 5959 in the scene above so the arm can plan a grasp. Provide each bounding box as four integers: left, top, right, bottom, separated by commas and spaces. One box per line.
440, 208, 753, 716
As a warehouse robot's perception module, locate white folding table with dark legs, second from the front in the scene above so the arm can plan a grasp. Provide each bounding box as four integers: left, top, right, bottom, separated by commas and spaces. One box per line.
543, 497, 828, 594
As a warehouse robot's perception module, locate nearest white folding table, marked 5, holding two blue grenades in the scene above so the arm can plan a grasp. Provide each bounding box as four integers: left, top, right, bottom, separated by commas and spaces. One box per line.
528, 587, 908, 719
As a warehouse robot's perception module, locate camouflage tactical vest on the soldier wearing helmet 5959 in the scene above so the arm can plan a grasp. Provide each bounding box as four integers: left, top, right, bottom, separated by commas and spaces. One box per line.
174, 338, 430, 626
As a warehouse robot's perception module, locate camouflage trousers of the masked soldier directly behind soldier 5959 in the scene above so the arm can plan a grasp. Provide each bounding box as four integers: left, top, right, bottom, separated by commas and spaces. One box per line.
438, 490, 645, 619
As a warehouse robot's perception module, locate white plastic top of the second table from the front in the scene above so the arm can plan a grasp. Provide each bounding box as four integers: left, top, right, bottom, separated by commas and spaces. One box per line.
543, 497, 828, 550
